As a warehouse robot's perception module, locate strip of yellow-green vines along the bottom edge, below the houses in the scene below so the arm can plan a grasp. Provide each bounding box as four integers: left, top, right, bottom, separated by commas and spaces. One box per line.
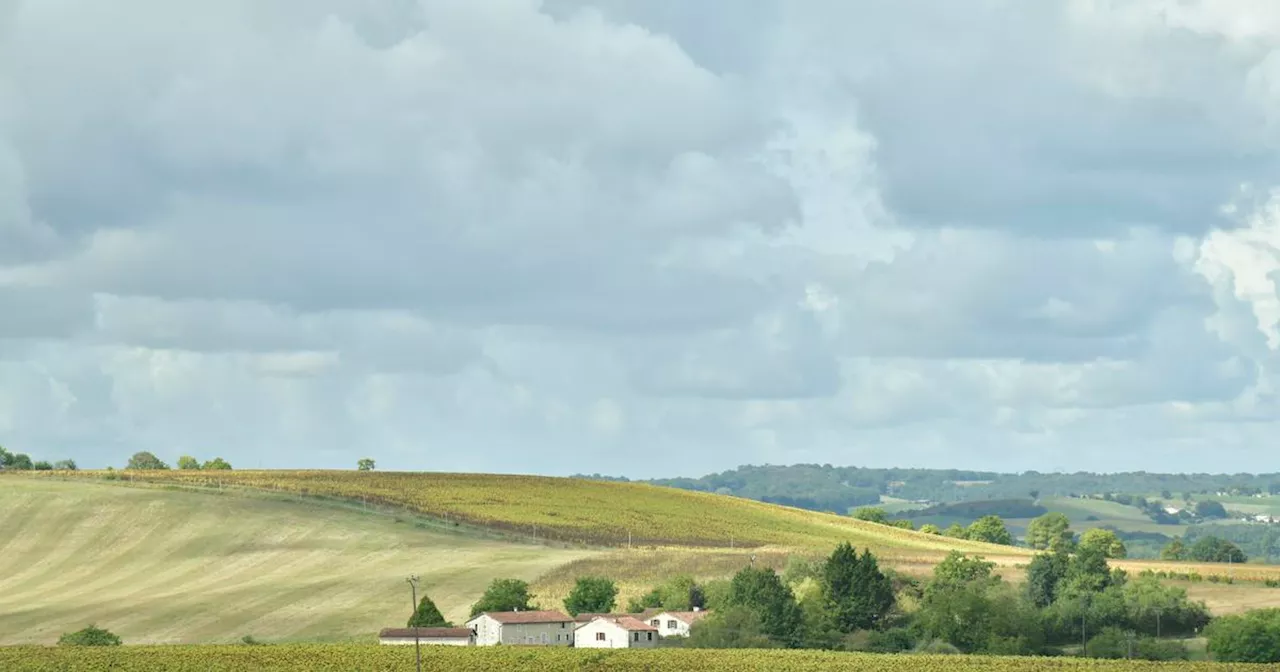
0, 644, 1268, 672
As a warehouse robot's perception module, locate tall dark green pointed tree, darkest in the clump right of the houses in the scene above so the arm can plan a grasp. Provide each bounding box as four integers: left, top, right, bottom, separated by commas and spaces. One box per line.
820, 541, 893, 632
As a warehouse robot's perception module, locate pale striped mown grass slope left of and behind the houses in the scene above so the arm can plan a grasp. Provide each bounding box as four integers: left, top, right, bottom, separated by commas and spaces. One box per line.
0, 477, 593, 644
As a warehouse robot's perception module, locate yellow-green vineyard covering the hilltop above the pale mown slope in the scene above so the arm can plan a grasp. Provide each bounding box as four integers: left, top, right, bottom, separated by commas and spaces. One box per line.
12, 470, 1028, 558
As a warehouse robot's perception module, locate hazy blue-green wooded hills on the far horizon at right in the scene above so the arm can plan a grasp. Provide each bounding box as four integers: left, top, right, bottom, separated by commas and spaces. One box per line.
579, 465, 1280, 513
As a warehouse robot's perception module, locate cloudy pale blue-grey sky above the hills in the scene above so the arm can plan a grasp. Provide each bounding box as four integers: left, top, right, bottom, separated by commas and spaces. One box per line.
0, 0, 1280, 477
